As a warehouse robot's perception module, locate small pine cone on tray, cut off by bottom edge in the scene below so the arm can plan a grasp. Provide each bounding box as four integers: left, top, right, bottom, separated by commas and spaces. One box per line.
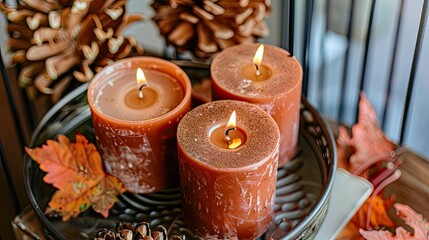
92, 222, 185, 240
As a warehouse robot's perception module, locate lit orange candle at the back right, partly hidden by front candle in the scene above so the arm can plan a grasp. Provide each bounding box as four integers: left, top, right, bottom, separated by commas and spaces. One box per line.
211, 44, 302, 166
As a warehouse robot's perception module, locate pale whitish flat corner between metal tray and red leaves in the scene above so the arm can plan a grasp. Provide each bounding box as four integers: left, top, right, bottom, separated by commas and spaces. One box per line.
315, 168, 373, 240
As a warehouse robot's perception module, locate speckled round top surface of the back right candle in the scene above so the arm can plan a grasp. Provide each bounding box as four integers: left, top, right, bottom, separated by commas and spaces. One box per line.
211, 44, 302, 98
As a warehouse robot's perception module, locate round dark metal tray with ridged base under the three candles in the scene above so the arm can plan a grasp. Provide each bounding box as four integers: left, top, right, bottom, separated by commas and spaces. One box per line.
25, 62, 336, 239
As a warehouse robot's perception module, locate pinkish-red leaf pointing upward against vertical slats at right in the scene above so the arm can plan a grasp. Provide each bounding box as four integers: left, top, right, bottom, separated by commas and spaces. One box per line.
350, 93, 395, 174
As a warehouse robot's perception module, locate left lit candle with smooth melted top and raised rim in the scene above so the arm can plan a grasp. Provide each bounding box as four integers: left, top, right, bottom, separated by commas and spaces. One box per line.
88, 57, 191, 193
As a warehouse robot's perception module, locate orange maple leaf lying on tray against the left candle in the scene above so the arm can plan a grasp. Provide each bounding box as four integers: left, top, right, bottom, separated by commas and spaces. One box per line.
25, 134, 125, 221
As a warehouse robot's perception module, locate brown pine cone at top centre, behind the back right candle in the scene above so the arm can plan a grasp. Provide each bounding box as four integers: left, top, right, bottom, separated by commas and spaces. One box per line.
152, 0, 271, 58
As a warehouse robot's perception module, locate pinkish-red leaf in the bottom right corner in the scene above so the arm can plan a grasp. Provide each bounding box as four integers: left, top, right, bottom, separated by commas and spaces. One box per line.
359, 203, 429, 240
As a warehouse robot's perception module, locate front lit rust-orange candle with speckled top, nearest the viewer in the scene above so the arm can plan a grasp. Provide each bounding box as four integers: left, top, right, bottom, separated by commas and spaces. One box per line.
177, 100, 280, 239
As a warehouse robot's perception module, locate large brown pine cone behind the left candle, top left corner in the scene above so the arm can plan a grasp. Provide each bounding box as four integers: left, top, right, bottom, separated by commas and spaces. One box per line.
0, 0, 143, 102
